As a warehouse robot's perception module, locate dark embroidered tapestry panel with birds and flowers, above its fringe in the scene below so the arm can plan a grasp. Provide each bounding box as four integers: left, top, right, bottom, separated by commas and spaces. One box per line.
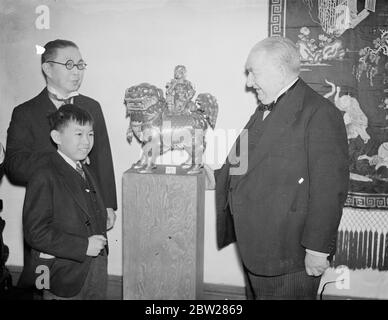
269, 0, 388, 209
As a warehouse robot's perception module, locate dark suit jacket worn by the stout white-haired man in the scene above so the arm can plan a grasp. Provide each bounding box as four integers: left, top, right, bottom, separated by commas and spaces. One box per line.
215, 79, 349, 276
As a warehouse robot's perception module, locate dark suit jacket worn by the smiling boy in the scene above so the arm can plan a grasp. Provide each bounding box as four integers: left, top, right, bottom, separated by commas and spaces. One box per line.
19, 153, 107, 297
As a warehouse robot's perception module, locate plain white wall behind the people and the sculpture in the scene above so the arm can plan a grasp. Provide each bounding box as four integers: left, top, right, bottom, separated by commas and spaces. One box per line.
0, 0, 268, 285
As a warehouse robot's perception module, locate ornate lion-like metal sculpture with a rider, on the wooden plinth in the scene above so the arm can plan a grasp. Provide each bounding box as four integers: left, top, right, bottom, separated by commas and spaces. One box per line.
124, 65, 218, 174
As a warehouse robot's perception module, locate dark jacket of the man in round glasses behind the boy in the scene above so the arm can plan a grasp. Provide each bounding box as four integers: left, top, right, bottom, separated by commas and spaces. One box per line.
5, 88, 117, 210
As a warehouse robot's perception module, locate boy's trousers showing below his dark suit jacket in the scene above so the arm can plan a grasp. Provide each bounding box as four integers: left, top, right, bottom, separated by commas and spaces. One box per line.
43, 254, 108, 300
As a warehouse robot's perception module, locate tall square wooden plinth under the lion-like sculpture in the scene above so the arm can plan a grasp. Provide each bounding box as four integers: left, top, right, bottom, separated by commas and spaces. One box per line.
123, 165, 205, 300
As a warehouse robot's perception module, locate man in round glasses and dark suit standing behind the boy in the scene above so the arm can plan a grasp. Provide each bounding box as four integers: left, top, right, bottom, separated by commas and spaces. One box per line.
5, 40, 117, 229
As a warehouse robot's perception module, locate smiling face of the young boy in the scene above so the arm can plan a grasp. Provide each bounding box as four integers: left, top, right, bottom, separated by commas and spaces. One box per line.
51, 121, 94, 162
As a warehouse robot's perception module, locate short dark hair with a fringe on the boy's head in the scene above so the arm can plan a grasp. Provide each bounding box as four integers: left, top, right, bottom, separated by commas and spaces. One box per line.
47, 104, 94, 131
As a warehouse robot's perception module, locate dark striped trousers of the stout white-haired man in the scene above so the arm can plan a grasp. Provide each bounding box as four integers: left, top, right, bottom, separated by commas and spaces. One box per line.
244, 268, 321, 300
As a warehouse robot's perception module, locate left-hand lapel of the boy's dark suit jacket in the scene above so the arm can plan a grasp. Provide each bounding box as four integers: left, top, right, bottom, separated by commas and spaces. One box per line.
54, 154, 90, 218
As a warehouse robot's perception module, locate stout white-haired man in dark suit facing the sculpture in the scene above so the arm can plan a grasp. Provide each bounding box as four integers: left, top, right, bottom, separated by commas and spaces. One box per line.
206, 37, 349, 299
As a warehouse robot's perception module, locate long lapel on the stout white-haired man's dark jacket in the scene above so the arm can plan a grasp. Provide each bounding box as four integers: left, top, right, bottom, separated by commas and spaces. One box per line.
236, 79, 305, 179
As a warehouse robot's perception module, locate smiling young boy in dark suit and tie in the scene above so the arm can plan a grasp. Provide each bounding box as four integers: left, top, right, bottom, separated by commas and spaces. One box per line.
19, 104, 108, 300
